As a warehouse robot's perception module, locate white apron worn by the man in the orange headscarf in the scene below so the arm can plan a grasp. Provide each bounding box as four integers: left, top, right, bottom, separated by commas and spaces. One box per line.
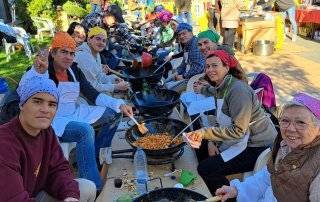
52, 68, 105, 137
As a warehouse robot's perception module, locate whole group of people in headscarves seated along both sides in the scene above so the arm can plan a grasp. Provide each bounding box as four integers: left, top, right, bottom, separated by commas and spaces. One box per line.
0, 1, 320, 201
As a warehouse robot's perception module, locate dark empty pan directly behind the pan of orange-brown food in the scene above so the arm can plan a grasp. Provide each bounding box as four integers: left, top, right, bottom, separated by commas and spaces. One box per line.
131, 88, 180, 117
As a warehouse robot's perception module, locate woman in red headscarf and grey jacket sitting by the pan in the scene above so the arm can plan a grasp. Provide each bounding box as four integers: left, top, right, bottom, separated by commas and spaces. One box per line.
186, 50, 277, 194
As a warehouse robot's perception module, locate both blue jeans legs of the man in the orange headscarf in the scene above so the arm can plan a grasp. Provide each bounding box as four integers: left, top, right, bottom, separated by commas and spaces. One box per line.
60, 108, 122, 190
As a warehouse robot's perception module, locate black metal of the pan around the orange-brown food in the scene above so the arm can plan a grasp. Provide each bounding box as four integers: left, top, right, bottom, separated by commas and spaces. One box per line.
125, 117, 187, 156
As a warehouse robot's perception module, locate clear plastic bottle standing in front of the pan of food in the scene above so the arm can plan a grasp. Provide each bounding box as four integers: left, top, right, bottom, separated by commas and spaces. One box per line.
133, 148, 148, 195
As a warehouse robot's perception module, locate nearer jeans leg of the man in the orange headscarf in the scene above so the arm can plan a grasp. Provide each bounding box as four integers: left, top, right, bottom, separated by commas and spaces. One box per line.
60, 121, 102, 190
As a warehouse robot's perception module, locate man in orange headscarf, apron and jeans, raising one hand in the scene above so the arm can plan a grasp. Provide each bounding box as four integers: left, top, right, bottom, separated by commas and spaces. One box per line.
19, 32, 132, 190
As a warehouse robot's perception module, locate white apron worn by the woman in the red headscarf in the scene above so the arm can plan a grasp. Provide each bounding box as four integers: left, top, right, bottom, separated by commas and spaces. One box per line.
216, 99, 249, 162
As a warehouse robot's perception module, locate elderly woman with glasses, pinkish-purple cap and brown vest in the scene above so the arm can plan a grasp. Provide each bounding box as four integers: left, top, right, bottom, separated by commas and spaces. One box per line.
216, 93, 320, 202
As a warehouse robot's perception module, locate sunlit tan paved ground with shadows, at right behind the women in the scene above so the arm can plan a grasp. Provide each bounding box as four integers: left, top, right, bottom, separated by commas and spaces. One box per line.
237, 38, 320, 104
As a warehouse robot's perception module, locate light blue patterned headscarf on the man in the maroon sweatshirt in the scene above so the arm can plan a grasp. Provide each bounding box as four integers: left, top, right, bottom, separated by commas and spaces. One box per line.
17, 76, 59, 106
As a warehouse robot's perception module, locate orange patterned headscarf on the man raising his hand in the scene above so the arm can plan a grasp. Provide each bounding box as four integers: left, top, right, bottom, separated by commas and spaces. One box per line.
51, 32, 77, 51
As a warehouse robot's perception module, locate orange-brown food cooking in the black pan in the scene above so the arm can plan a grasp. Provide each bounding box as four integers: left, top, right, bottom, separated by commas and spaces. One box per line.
133, 132, 182, 150
